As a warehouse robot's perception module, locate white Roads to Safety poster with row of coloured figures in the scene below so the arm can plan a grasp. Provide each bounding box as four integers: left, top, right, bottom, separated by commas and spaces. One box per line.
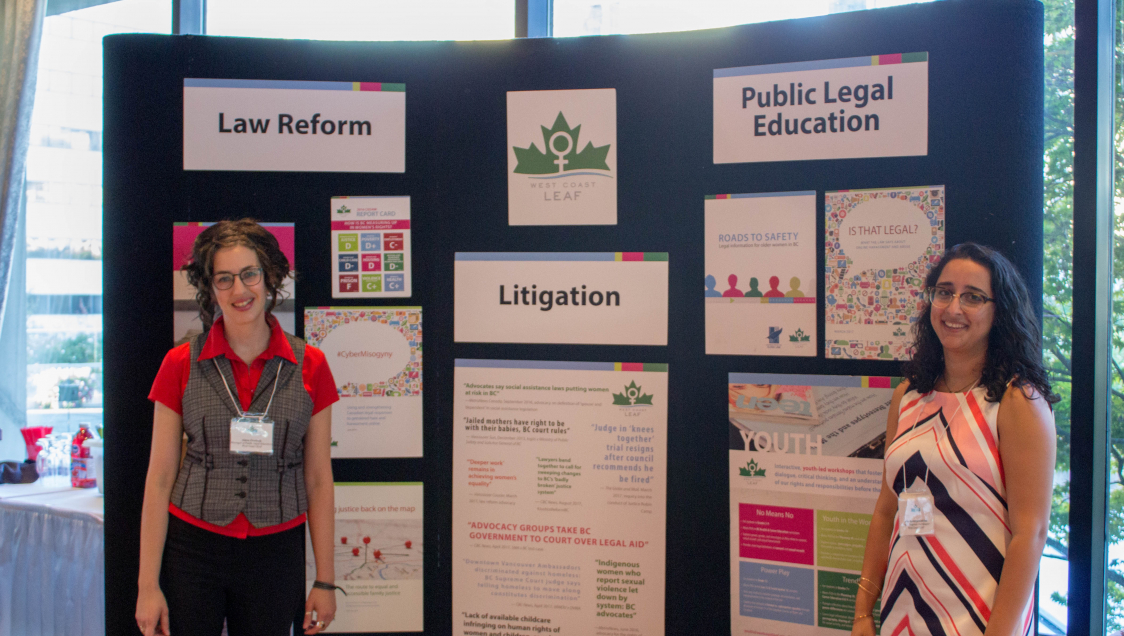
704, 191, 818, 356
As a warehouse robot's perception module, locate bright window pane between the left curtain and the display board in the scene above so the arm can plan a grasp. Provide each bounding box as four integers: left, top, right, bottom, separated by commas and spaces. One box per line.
27, 0, 172, 430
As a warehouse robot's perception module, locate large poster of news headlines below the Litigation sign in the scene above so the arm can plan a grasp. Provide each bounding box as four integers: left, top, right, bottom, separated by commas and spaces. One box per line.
453, 360, 668, 636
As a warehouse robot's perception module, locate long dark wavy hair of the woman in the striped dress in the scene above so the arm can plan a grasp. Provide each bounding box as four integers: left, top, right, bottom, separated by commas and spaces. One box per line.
901, 243, 1061, 405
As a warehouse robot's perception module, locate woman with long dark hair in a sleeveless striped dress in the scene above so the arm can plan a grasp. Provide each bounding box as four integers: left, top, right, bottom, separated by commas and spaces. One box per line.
851, 243, 1058, 636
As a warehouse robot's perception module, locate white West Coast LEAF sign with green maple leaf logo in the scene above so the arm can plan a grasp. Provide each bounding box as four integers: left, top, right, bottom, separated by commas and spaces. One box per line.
507, 89, 617, 225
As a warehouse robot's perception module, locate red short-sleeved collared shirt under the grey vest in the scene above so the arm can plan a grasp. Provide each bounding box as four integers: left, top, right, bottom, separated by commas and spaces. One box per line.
148, 317, 339, 538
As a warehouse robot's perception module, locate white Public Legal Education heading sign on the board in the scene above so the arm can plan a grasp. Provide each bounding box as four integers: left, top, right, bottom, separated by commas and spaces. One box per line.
714, 52, 928, 163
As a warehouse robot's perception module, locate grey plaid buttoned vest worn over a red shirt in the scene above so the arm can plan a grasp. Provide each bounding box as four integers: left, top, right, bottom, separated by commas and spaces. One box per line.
172, 334, 312, 528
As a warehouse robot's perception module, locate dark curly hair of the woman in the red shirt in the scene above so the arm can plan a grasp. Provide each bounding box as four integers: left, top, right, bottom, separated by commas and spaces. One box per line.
180, 218, 294, 331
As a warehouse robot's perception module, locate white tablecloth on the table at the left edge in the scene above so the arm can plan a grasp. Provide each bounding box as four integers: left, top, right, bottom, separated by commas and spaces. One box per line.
0, 484, 106, 636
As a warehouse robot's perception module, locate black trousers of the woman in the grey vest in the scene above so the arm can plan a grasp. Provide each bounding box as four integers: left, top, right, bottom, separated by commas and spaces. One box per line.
161, 515, 305, 636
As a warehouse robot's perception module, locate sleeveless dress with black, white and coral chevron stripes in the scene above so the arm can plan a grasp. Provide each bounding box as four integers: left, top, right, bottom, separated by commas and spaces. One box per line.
881, 387, 1033, 636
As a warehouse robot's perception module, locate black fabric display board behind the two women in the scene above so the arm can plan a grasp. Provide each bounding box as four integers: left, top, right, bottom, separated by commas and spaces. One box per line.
103, 0, 1043, 635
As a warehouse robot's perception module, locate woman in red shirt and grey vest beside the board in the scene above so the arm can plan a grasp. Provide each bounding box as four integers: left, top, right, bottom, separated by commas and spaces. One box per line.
136, 219, 338, 636
